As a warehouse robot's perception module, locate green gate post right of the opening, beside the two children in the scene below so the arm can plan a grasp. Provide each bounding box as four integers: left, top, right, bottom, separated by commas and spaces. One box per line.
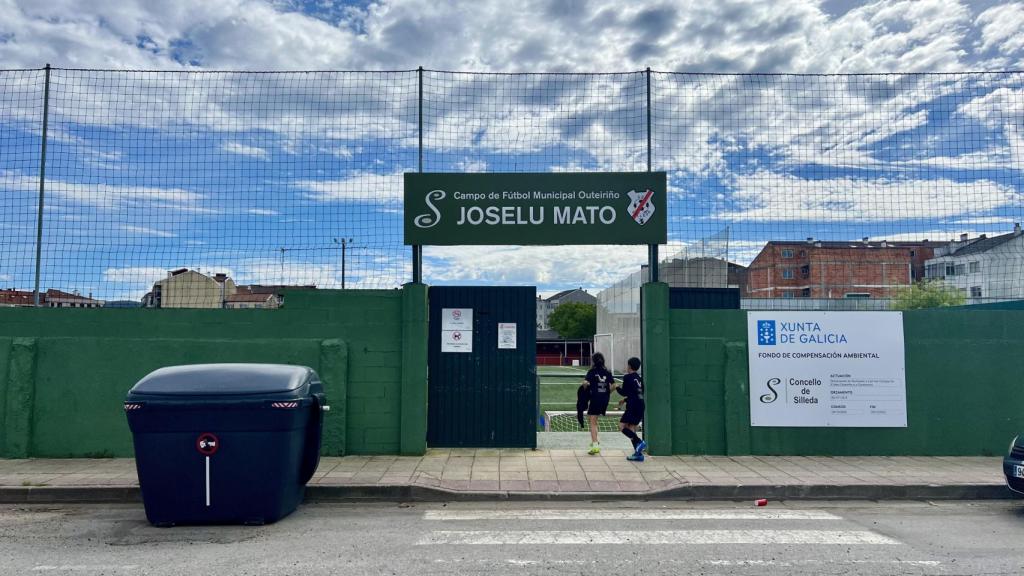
640, 282, 673, 456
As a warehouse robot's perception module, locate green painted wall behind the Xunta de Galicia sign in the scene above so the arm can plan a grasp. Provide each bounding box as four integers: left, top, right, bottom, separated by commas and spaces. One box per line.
670, 308, 1024, 455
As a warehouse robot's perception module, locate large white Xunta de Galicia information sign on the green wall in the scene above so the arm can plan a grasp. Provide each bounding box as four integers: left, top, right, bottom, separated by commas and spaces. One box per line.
746, 312, 906, 427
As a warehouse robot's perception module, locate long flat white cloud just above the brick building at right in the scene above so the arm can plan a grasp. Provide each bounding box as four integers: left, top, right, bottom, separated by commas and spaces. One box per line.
716, 170, 1022, 222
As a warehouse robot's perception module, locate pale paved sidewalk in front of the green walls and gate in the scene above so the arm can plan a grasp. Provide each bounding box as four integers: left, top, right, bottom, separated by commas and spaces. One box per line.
0, 449, 1012, 503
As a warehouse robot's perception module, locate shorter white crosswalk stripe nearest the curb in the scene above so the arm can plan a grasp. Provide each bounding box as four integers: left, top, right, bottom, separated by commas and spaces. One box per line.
423, 508, 840, 521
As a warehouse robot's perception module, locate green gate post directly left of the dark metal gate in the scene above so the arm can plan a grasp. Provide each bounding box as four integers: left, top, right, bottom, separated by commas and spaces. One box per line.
399, 283, 429, 455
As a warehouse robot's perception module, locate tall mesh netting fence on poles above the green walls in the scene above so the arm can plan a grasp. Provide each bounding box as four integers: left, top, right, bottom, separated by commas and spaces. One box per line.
0, 69, 1024, 308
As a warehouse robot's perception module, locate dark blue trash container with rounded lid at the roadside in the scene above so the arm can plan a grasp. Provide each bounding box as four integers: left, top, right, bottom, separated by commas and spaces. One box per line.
125, 364, 330, 526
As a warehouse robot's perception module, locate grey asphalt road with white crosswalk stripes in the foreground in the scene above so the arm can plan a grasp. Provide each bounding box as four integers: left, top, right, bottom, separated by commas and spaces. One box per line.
0, 501, 1024, 576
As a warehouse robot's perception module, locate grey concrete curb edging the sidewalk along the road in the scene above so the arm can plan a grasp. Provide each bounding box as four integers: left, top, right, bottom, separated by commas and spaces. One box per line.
0, 484, 1017, 504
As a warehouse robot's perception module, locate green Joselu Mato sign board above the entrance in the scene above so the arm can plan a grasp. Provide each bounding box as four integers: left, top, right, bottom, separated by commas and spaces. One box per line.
406, 172, 668, 246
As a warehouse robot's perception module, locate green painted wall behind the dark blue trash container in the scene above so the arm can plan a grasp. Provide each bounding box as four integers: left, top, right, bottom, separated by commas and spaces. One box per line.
0, 290, 426, 457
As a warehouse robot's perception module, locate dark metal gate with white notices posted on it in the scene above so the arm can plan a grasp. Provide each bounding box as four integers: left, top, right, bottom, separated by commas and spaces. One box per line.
427, 286, 538, 448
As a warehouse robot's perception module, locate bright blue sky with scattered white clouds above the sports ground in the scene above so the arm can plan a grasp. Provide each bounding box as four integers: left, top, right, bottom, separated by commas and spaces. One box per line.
0, 0, 1024, 299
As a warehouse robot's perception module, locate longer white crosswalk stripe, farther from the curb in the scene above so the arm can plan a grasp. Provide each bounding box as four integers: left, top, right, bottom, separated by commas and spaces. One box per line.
417, 530, 899, 545
